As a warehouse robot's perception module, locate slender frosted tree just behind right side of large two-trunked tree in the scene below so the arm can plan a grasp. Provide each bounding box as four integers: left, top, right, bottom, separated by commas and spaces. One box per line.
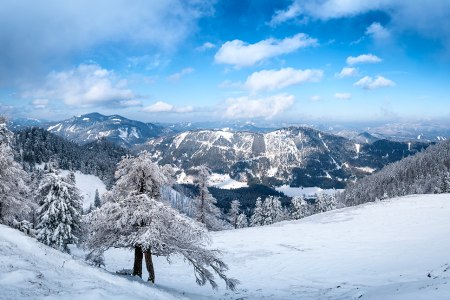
194, 165, 223, 230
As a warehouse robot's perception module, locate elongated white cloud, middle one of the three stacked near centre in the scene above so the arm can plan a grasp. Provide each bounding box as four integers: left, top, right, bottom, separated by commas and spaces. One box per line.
244, 68, 323, 92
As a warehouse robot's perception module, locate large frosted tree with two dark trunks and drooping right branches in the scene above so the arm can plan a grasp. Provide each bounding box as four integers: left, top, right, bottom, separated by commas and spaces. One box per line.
86, 152, 238, 289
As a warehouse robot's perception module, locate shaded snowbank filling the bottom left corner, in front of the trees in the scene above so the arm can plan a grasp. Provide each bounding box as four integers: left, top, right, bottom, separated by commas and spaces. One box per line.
0, 225, 185, 300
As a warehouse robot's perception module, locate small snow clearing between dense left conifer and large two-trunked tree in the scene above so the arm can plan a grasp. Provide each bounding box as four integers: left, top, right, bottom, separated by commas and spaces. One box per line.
61, 170, 106, 209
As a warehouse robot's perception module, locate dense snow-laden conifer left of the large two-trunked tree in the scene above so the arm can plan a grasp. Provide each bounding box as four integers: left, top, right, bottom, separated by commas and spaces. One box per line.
36, 167, 82, 252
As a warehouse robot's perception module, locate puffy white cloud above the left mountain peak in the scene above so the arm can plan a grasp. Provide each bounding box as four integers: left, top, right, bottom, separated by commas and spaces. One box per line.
23, 64, 136, 107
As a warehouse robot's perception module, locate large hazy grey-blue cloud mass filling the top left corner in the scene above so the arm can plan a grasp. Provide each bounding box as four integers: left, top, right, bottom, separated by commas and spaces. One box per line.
0, 0, 215, 82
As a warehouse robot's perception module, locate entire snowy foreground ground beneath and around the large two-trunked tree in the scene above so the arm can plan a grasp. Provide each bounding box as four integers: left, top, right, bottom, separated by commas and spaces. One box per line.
0, 194, 450, 300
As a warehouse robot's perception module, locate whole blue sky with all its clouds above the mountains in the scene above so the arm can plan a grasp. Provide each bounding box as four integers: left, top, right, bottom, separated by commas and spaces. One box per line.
0, 0, 450, 122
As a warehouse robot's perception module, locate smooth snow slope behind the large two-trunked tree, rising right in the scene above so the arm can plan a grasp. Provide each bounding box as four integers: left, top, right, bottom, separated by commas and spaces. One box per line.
106, 194, 450, 300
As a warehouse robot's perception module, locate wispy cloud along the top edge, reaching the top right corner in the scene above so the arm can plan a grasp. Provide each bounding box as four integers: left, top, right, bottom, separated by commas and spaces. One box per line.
270, 0, 450, 50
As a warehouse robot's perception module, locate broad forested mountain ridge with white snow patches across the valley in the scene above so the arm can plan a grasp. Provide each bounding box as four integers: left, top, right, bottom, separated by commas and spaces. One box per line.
145, 127, 428, 188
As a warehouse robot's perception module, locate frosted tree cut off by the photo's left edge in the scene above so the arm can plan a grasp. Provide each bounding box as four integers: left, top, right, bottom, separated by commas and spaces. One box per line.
0, 117, 32, 225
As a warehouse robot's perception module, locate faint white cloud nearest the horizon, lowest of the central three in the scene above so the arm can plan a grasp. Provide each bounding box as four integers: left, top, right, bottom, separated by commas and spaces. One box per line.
224, 94, 295, 119
